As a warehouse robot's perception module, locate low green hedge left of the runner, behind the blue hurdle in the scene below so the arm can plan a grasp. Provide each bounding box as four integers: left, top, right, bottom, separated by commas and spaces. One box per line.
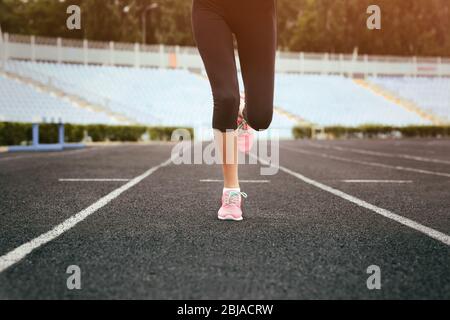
0, 122, 194, 146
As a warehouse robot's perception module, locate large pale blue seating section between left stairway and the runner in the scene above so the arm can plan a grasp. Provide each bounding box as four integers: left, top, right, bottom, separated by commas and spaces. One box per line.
3, 61, 295, 137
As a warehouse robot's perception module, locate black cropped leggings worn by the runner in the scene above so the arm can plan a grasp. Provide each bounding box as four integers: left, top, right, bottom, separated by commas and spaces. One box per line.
192, 0, 277, 132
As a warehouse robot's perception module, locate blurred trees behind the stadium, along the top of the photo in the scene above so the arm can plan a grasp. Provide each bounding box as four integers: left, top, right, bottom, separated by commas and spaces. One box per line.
0, 0, 450, 56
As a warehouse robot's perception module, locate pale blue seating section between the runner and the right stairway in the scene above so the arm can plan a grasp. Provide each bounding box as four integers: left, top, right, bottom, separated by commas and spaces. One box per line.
275, 74, 429, 126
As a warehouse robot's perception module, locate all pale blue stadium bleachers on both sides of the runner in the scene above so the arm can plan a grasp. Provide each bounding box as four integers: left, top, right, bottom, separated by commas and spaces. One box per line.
0, 60, 450, 137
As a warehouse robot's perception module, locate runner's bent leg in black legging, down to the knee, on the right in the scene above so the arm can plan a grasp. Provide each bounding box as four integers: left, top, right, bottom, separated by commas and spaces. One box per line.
232, 0, 277, 130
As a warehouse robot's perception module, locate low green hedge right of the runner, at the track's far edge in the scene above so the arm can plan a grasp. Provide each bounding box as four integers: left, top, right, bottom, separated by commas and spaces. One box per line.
293, 125, 450, 139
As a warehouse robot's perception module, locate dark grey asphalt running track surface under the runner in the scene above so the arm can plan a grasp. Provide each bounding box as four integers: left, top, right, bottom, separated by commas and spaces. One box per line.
0, 140, 450, 299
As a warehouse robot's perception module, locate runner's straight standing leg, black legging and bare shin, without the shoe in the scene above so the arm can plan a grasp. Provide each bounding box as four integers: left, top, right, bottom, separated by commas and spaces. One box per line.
192, 0, 240, 188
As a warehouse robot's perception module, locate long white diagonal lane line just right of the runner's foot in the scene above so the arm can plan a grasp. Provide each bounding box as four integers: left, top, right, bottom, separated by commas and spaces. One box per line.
250, 154, 450, 246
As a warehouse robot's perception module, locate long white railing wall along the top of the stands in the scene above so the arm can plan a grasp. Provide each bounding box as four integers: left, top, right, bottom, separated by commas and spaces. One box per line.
0, 33, 450, 77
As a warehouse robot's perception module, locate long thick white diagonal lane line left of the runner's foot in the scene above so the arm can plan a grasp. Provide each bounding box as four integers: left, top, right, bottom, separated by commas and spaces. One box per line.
0, 159, 172, 273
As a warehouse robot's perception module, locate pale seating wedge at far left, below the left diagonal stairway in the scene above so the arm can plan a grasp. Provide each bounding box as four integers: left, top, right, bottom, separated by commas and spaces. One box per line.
0, 76, 115, 124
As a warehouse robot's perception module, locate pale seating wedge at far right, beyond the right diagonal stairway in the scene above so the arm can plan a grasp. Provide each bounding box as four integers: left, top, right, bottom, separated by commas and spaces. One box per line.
370, 77, 450, 122
